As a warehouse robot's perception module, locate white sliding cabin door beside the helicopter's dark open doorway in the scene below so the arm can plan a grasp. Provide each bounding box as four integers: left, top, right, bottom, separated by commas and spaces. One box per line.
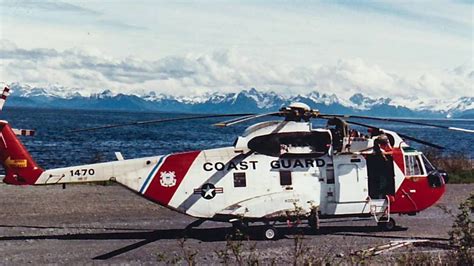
334, 155, 368, 203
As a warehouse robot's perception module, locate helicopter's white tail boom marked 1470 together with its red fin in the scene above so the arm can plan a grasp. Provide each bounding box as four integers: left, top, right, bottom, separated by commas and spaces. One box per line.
0, 120, 162, 191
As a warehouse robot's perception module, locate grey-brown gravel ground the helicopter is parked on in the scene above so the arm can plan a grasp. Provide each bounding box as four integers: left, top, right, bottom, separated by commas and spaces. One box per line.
0, 183, 474, 265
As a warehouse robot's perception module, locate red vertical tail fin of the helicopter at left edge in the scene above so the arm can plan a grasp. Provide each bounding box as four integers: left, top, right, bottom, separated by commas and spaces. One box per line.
0, 121, 44, 185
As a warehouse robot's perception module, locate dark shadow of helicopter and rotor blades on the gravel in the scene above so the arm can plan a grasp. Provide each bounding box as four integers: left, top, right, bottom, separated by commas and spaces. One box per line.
0, 222, 446, 260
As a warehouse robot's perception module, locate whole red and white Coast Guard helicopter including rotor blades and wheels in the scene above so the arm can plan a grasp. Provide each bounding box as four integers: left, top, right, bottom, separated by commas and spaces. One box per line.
0, 88, 474, 239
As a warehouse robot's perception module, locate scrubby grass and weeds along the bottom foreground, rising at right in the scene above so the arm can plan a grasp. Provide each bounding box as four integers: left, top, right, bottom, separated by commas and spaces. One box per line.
157, 194, 474, 265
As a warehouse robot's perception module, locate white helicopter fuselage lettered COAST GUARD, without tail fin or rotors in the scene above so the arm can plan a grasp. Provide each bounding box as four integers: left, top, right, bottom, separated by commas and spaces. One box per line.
25, 119, 444, 221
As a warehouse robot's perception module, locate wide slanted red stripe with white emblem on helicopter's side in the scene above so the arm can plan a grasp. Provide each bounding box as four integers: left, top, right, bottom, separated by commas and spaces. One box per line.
144, 151, 200, 206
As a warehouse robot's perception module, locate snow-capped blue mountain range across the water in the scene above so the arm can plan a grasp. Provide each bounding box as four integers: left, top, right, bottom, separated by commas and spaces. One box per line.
7, 83, 474, 118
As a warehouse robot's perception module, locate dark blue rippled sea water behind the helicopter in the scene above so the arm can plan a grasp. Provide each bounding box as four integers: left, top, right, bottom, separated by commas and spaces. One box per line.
0, 108, 474, 168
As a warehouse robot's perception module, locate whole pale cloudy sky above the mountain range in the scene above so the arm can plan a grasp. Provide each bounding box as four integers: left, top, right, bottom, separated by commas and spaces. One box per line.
0, 0, 474, 99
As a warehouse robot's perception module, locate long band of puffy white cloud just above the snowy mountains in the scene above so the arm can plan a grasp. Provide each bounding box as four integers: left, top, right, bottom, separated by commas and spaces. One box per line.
0, 40, 474, 102
